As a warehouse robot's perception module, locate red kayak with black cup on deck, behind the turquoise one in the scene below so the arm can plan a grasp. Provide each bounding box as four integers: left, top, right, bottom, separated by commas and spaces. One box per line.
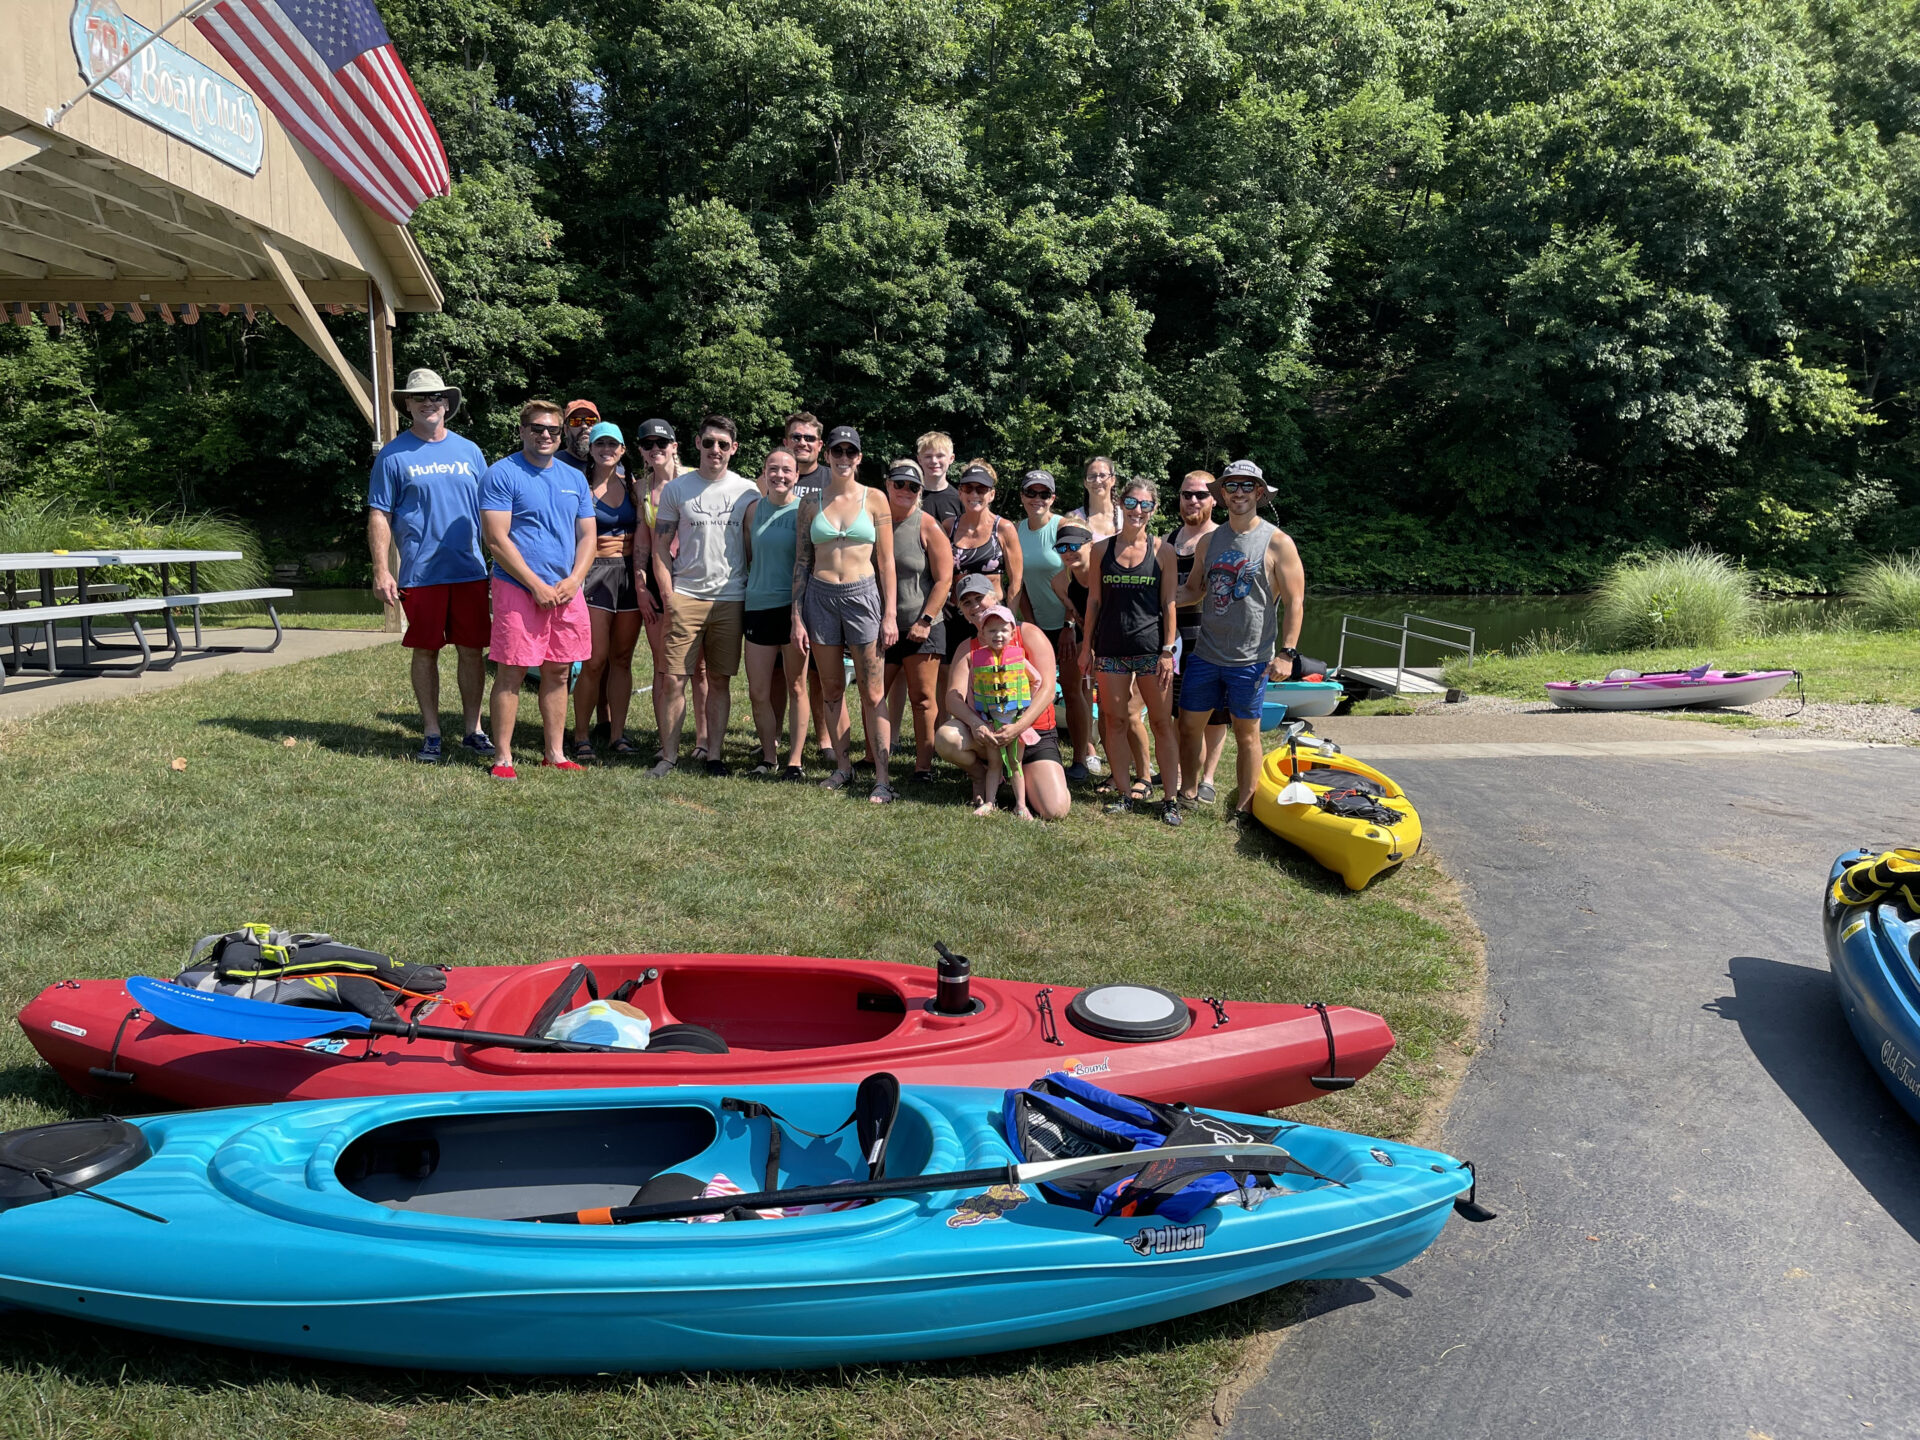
19, 954, 1394, 1114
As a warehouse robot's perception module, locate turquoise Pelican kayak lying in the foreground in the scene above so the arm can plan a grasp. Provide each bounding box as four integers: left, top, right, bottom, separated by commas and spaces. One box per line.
0, 1085, 1471, 1373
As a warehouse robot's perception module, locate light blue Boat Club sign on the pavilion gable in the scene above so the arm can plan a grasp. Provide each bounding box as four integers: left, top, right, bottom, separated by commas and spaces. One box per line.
73, 0, 265, 175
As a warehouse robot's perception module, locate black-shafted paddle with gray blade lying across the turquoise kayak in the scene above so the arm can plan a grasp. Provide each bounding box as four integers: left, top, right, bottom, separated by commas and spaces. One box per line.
520, 1142, 1320, 1225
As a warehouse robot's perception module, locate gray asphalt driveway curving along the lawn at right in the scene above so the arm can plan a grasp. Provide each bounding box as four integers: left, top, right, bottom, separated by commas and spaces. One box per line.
1229, 737, 1920, 1440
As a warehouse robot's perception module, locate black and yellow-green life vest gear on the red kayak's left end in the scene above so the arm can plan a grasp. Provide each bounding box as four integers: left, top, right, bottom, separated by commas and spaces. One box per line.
179, 925, 447, 1020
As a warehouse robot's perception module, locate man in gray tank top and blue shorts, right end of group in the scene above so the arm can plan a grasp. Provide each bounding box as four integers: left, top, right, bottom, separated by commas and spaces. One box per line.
1179, 461, 1306, 810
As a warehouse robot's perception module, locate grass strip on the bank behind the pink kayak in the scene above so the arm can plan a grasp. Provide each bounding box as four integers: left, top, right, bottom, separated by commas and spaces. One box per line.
1446, 630, 1920, 705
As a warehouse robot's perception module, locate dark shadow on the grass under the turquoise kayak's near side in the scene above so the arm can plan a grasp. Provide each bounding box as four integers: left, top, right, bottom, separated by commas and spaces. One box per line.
0, 1279, 1320, 1405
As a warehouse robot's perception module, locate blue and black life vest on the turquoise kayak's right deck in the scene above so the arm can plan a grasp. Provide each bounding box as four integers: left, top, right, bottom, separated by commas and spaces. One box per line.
1000, 1069, 1286, 1221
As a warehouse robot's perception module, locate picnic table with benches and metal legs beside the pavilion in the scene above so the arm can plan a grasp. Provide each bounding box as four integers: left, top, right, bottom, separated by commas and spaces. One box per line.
0, 549, 294, 685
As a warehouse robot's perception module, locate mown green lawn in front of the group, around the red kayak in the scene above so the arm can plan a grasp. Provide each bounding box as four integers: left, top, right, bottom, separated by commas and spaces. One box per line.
0, 649, 1476, 1440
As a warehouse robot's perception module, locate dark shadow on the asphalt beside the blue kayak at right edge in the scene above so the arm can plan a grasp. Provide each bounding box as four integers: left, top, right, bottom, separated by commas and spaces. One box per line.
1701, 954, 1920, 1240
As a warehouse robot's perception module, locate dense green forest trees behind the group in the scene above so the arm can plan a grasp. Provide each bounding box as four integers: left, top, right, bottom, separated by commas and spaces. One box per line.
0, 0, 1920, 589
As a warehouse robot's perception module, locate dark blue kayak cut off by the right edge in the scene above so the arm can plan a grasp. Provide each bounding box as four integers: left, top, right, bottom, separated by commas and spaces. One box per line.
1822, 851, 1920, 1119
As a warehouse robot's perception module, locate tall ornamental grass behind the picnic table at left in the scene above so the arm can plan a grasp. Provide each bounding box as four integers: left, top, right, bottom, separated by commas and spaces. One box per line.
0, 495, 267, 595
